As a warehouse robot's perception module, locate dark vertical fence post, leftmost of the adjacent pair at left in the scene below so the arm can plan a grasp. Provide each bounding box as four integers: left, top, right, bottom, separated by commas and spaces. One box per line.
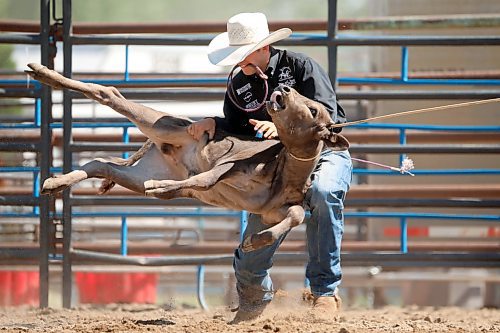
39, 0, 52, 308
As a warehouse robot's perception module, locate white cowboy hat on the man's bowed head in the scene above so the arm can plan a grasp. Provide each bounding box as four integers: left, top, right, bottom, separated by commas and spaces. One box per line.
208, 13, 292, 66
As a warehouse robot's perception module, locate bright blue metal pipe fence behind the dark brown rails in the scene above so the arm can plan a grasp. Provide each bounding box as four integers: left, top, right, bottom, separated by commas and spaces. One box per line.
0, 83, 500, 274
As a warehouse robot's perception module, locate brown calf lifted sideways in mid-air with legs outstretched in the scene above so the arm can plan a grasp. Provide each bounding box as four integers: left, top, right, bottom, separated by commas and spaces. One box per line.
26, 64, 349, 251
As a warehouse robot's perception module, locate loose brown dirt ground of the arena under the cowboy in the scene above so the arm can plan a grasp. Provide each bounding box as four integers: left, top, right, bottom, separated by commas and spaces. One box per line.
0, 301, 500, 333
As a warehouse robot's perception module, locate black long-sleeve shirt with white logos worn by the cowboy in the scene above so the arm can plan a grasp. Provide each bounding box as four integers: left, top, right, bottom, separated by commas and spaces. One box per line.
214, 47, 346, 136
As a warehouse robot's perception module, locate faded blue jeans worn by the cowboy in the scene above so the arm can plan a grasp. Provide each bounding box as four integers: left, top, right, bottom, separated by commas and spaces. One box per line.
233, 150, 352, 303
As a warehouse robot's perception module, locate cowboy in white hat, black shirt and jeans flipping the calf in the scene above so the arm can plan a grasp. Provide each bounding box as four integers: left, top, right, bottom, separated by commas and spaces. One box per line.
188, 13, 352, 323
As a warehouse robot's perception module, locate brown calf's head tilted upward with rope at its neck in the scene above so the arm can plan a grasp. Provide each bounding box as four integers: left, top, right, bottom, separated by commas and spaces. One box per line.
267, 86, 349, 150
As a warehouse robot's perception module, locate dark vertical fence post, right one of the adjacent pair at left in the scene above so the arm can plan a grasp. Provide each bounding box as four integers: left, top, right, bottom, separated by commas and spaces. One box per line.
62, 0, 73, 308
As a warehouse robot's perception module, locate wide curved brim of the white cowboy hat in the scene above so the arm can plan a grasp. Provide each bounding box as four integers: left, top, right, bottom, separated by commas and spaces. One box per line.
208, 28, 292, 66
